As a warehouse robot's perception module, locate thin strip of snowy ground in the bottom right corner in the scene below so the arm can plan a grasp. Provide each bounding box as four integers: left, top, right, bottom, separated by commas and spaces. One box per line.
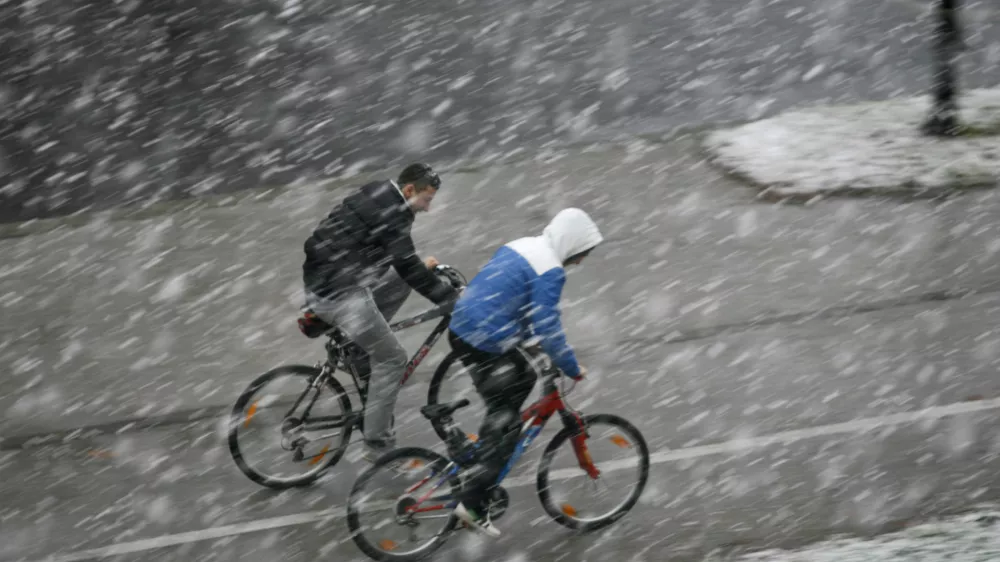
724, 509, 1000, 562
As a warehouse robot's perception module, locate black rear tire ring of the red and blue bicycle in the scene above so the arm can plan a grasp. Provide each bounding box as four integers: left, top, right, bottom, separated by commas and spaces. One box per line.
347, 447, 462, 562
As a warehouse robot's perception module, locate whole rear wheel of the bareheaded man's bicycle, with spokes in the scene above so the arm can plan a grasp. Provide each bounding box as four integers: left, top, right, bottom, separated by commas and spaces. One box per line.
229, 365, 353, 490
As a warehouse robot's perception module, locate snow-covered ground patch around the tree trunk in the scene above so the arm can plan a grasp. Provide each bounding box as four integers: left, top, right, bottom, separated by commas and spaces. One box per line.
705, 88, 1000, 197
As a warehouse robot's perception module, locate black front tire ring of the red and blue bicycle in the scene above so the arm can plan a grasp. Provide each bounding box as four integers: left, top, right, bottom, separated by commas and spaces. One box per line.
536, 414, 649, 533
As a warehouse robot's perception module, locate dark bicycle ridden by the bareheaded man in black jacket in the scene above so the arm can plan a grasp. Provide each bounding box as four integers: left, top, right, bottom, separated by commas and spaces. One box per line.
228, 265, 467, 490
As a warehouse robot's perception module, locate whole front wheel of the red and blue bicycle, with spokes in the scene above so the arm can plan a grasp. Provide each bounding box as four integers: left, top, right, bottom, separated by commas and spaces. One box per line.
537, 414, 649, 533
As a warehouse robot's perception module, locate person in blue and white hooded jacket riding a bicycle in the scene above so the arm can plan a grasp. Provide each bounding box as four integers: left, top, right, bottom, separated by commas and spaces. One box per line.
448, 208, 603, 537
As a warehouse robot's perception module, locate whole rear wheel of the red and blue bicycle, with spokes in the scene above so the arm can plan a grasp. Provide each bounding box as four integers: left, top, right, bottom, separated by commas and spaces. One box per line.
347, 447, 461, 562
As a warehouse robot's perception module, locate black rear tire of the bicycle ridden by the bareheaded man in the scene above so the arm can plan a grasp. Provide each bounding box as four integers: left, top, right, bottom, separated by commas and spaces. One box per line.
228, 365, 354, 490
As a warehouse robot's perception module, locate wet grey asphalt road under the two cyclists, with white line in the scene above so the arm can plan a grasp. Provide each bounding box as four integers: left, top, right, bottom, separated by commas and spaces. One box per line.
0, 137, 1000, 562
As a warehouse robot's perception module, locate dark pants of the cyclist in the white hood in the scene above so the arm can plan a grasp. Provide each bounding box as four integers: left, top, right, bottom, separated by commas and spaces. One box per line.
448, 330, 535, 514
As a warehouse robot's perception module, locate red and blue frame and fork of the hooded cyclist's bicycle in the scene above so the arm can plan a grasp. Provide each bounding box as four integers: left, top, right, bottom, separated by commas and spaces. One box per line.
406, 372, 600, 514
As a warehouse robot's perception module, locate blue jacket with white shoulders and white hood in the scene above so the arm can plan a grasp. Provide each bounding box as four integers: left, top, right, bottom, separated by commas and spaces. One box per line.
449, 208, 603, 378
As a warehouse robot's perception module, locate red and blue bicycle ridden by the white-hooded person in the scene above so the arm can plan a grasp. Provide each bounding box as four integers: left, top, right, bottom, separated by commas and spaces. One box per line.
347, 347, 649, 562
